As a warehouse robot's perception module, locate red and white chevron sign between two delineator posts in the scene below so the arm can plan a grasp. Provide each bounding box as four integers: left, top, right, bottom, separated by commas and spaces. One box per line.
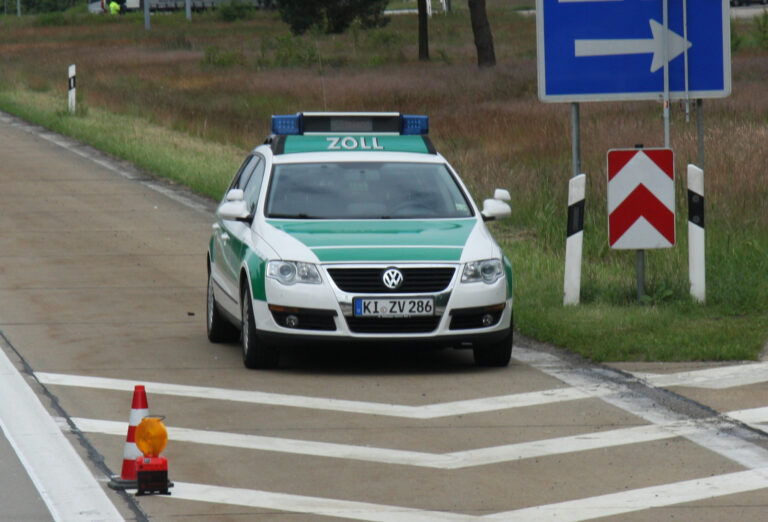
608, 149, 675, 250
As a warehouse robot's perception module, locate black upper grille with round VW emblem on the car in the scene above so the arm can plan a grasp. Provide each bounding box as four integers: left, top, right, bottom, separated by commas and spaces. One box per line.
328, 267, 456, 294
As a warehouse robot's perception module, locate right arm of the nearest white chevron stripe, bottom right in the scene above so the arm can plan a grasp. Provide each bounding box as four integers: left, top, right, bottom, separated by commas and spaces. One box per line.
485, 468, 768, 522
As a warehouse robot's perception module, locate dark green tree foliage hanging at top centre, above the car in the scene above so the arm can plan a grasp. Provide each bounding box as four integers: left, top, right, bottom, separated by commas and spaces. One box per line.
278, 0, 389, 35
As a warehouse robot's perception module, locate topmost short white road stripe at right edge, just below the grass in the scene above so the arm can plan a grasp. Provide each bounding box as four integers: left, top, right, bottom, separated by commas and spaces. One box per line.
633, 363, 768, 390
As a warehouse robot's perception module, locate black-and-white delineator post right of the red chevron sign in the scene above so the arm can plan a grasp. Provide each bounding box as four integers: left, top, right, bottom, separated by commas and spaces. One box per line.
688, 165, 707, 303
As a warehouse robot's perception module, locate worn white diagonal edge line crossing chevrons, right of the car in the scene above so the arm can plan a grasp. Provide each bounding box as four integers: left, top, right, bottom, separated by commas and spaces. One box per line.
515, 348, 768, 469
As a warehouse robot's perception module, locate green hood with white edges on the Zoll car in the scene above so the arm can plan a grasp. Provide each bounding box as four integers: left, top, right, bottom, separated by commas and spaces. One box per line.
265, 218, 500, 263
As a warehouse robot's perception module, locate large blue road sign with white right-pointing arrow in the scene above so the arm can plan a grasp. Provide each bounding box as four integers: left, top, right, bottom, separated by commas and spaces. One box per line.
536, 0, 731, 102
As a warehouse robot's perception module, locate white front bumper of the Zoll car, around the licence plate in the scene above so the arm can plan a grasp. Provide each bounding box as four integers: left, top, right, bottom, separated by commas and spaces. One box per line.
253, 264, 513, 346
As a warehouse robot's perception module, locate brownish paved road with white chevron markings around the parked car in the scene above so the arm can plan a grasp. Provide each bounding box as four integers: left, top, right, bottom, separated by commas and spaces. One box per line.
0, 113, 768, 522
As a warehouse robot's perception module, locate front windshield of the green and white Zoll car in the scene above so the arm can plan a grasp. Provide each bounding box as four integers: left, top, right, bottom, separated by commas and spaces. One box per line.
265, 162, 473, 219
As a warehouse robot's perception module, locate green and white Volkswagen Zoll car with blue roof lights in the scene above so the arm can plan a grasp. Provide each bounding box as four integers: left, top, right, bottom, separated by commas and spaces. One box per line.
207, 113, 513, 368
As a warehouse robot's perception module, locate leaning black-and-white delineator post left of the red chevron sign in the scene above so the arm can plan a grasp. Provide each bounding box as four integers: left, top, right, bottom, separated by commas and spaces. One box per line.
563, 174, 587, 305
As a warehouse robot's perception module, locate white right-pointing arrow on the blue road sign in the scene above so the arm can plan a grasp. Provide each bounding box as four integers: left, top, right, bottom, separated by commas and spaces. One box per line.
575, 19, 693, 73
